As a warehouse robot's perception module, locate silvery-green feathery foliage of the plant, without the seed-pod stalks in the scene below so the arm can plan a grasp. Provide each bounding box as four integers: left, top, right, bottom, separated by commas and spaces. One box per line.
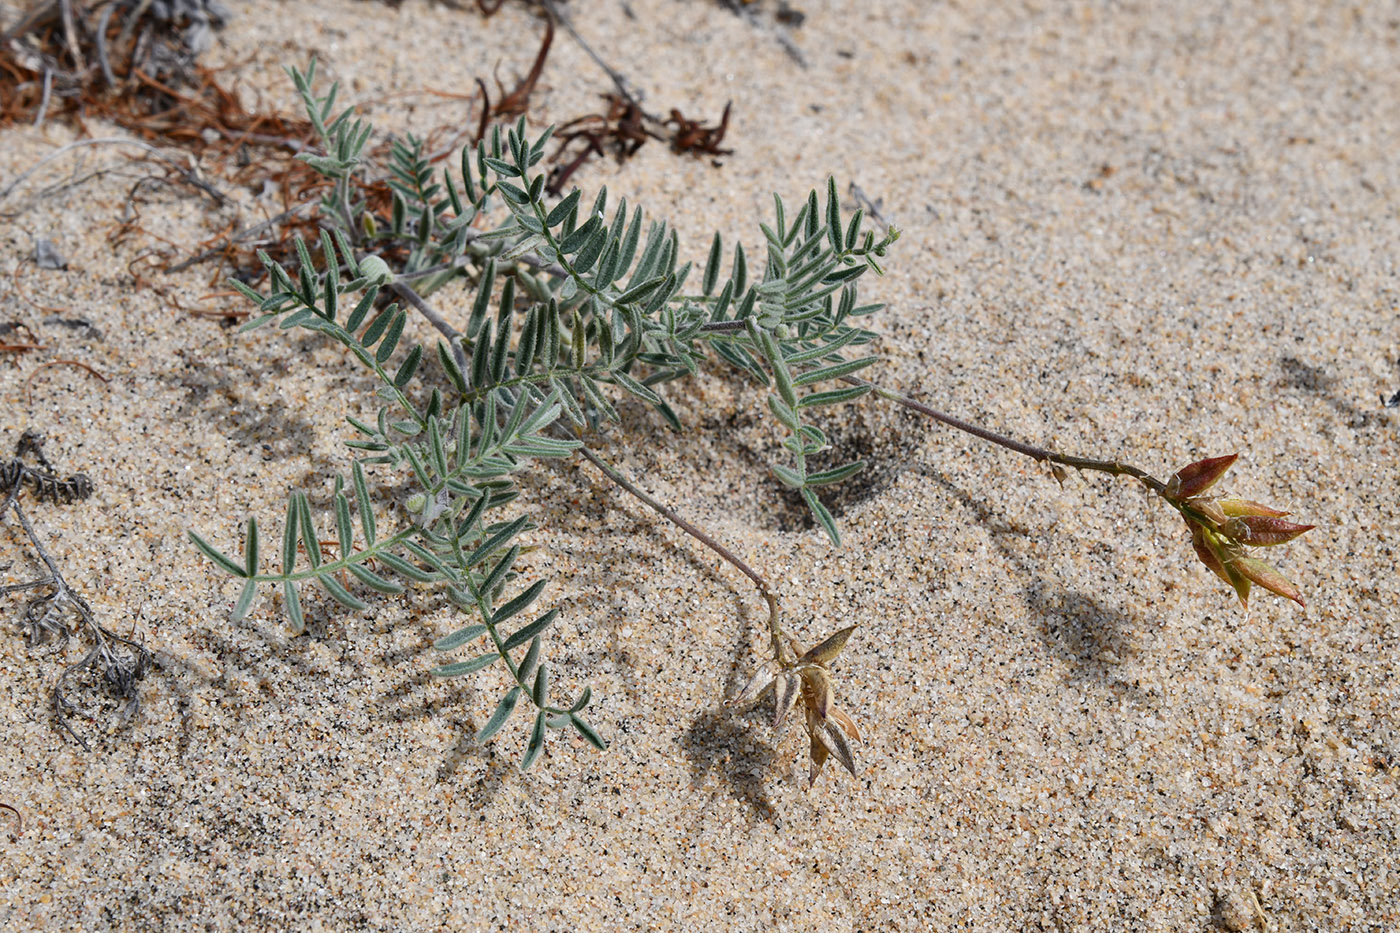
203, 70, 929, 768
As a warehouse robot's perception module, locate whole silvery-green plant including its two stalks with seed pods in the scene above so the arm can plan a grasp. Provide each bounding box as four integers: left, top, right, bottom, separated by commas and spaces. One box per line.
192, 66, 1308, 780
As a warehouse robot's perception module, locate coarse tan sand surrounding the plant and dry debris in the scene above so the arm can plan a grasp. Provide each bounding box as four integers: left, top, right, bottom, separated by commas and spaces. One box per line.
0, 0, 1400, 933
